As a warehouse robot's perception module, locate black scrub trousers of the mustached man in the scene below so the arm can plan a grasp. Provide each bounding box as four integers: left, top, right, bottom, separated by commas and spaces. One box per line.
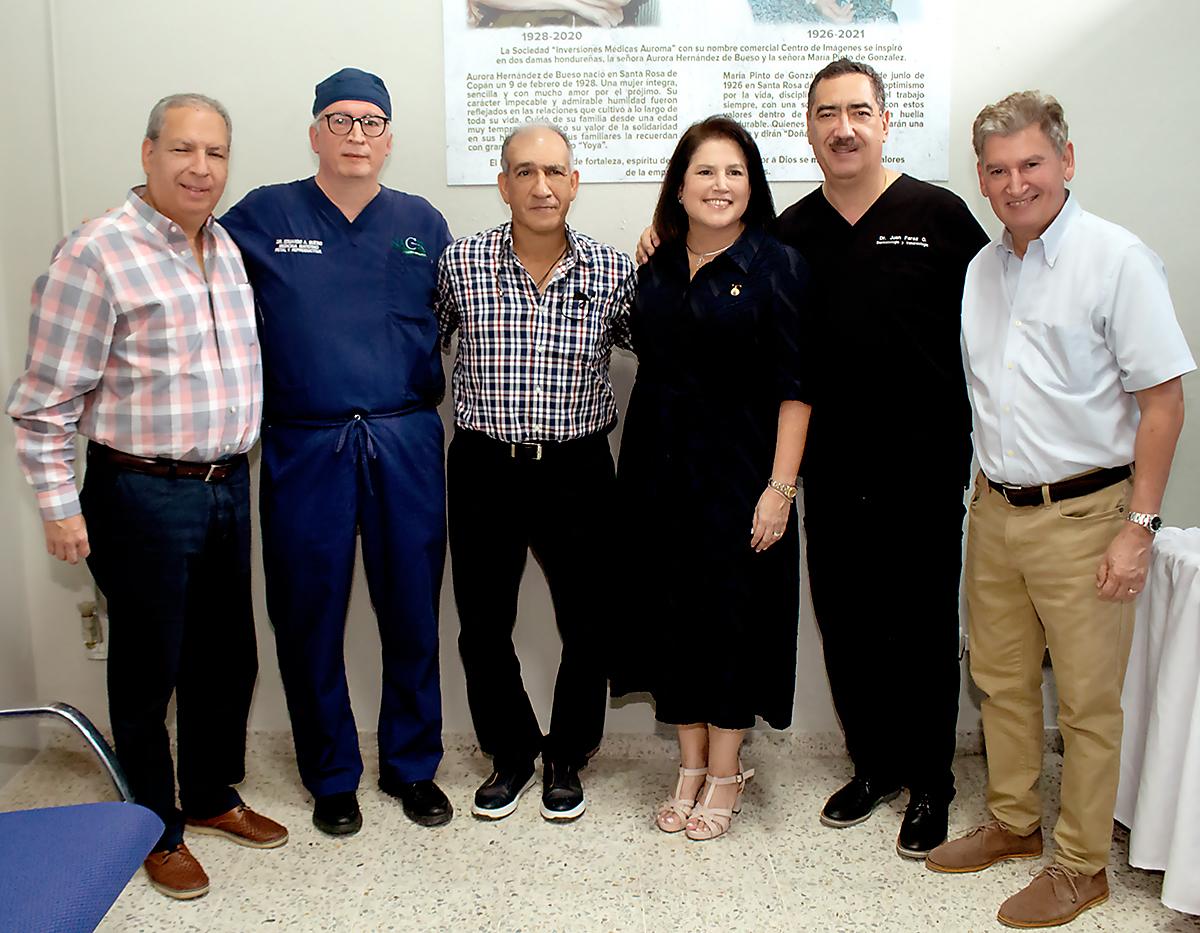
804, 477, 965, 799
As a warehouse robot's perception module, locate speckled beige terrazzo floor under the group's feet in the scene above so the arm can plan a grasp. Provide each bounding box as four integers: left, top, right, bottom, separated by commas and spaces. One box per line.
0, 734, 1200, 933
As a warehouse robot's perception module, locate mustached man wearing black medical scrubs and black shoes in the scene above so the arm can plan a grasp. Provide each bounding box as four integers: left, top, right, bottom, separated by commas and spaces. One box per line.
638, 59, 988, 859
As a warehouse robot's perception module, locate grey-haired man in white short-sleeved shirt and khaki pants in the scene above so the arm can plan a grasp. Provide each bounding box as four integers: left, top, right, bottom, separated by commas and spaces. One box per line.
926, 91, 1195, 927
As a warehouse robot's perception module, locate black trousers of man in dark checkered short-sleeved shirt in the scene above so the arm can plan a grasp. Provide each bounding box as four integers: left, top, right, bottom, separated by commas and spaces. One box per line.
446, 429, 616, 766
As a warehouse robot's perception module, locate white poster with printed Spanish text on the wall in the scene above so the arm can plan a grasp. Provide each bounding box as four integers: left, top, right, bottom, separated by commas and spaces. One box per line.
443, 0, 952, 185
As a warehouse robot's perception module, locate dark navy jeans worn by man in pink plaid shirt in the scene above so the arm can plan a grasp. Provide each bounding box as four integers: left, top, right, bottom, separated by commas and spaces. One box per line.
80, 446, 258, 849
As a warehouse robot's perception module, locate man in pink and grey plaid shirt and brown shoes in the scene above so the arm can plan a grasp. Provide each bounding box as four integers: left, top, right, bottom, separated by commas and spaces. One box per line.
7, 95, 288, 898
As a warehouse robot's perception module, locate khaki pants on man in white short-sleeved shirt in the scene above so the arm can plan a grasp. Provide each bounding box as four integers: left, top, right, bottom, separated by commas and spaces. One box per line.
965, 474, 1134, 874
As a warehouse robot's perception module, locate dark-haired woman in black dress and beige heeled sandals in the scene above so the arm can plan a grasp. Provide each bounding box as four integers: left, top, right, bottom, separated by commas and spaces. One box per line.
613, 116, 809, 839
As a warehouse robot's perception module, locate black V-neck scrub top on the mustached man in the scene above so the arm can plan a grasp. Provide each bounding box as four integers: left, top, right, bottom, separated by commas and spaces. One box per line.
776, 175, 988, 484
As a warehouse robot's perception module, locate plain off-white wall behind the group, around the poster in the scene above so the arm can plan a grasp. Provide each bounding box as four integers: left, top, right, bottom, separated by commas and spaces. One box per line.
0, 0, 1200, 757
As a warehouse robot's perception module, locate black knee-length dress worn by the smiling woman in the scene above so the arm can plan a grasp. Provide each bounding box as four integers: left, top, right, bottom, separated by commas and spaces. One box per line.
612, 223, 809, 729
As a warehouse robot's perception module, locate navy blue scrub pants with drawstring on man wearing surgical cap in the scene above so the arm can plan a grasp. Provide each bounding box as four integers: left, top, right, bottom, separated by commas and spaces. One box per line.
260, 409, 445, 796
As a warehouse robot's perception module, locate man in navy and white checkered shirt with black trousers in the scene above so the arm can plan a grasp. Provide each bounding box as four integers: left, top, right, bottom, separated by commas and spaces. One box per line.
438, 124, 634, 820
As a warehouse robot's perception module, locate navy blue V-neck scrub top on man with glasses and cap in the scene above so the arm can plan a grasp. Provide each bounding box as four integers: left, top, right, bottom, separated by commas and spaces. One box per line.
221, 177, 451, 421
